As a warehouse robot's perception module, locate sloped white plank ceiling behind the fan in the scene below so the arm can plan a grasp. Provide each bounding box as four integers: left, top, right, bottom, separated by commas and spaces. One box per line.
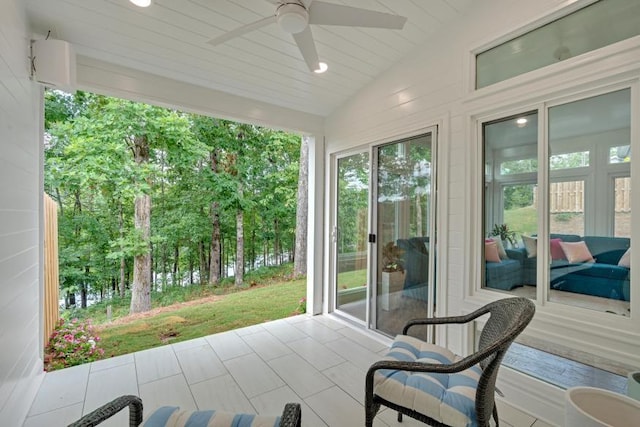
26, 0, 472, 116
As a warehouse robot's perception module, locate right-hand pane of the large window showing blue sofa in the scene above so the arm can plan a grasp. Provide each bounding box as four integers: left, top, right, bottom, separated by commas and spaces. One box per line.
547, 89, 634, 316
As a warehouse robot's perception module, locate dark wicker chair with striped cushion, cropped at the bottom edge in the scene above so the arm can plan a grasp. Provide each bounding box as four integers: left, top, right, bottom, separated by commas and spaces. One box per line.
69, 396, 302, 427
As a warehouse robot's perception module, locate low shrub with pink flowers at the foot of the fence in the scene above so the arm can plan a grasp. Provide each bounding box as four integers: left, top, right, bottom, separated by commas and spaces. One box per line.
44, 319, 104, 371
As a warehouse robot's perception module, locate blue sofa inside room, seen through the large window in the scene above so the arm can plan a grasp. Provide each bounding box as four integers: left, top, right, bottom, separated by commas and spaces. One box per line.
511, 234, 631, 301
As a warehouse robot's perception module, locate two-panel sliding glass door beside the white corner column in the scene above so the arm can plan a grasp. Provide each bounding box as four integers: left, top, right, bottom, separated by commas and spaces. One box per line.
331, 128, 436, 336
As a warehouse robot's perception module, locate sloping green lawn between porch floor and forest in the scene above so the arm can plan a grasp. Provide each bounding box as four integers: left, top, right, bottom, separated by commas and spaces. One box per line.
66, 268, 306, 357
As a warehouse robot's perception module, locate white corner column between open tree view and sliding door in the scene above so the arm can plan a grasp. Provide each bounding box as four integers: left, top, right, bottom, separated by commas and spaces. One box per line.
307, 135, 325, 314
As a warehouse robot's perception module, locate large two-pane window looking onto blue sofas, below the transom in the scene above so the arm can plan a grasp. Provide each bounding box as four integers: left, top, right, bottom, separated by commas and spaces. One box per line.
482, 87, 632, 317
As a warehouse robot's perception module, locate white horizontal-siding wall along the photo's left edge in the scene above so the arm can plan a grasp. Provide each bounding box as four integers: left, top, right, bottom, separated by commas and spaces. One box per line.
0, 0, 42, 426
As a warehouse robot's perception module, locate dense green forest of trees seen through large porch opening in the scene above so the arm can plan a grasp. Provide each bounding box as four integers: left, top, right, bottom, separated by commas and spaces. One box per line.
44, 91, 306, 312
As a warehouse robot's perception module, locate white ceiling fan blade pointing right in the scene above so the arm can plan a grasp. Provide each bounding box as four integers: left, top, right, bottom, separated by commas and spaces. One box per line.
309, 0, 407, 30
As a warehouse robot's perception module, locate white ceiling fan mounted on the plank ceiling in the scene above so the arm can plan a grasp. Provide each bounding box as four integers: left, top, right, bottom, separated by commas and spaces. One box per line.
209, 0, 407, 71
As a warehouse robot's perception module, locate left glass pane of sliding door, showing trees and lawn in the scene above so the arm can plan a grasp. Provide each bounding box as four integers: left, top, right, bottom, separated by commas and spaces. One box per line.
333, 152, 369, 322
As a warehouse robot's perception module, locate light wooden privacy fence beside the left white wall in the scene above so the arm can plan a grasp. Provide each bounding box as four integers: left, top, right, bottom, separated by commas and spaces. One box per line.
43, 194, 60, 347
